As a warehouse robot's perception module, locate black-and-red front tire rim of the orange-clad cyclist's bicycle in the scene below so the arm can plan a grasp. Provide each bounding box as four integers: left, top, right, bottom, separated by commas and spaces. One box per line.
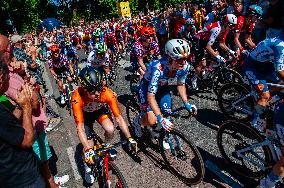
104, 161, 128, 188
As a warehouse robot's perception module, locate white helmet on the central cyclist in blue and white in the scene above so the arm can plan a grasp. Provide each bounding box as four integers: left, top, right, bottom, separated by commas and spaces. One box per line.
165, 39, 190, 60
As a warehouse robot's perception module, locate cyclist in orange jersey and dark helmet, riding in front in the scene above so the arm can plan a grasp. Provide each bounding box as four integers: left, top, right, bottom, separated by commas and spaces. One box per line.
71, 66, 137, 183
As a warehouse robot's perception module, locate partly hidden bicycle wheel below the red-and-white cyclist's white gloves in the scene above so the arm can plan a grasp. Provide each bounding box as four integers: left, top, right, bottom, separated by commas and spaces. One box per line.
212, 68, 243, 95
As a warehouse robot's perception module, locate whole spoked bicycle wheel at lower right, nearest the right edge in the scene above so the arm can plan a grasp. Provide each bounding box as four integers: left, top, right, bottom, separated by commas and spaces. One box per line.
217, 121, 272, 179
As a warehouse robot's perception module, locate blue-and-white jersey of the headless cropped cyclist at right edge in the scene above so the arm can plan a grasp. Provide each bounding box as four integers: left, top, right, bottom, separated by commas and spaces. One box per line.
250, 37, 284, 71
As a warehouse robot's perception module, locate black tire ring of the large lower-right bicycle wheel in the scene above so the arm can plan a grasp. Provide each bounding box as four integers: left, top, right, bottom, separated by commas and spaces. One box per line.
217, 120, 272, 179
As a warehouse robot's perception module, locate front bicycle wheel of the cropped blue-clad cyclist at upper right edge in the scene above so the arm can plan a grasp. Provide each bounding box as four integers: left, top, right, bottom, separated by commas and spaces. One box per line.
217, 83, 254, 122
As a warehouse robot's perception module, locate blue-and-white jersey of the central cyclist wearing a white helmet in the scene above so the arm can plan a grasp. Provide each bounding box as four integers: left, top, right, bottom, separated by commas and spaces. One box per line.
144, 58, 190, 94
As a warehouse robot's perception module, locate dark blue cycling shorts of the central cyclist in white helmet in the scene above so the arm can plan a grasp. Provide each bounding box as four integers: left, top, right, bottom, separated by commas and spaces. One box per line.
139, 78, 172, 113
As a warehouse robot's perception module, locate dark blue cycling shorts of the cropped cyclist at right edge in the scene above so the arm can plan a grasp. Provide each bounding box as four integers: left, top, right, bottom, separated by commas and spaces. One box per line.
244, 57, 280, 92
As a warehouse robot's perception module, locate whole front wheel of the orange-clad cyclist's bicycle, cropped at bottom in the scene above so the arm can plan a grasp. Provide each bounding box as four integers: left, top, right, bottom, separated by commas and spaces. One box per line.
104, 161, 128, 188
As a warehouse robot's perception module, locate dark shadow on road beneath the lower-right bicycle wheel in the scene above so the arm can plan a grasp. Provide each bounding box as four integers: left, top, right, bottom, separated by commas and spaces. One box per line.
198, 147, 256, 187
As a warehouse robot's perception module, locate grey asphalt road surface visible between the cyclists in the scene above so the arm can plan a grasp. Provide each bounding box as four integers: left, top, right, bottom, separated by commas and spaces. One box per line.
44, 50, 254, 188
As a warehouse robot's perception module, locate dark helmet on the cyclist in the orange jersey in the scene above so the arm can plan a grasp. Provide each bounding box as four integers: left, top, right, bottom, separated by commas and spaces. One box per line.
78, 66, 103, 91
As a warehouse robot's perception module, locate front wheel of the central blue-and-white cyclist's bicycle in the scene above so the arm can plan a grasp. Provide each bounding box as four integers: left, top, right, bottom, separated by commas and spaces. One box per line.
159, 129, 205, 185
